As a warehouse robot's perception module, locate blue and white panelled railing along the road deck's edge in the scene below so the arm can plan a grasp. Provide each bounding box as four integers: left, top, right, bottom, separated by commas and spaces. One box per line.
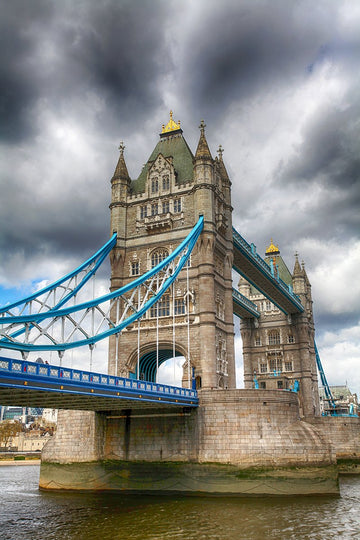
0, 357, 197, 400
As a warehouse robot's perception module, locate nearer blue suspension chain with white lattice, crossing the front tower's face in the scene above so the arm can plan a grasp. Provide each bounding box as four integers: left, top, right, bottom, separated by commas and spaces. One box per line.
0, 216, 204, 352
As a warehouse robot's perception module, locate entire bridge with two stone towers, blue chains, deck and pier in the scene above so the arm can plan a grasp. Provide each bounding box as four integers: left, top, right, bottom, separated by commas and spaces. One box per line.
0, 114, 360, 491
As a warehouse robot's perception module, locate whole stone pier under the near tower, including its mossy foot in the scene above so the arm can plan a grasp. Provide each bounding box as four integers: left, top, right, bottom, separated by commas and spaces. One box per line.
40, 389, 358, 495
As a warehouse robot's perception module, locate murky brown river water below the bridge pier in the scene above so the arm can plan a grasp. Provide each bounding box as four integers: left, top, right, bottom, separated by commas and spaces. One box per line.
0, 465, 360, 540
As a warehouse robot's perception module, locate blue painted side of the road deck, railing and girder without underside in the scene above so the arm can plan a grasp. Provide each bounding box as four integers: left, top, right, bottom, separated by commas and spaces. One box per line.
0, 356, 199, 407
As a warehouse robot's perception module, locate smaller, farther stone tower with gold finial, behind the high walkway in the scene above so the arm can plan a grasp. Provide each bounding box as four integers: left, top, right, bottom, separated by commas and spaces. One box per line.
239, 240, 320, 416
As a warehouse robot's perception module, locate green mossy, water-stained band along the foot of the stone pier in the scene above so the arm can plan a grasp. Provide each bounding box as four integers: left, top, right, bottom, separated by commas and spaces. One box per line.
40, 461, 339, 496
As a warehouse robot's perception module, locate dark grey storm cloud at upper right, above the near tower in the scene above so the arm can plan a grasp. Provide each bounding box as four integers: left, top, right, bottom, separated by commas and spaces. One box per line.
180, 0, 344, 121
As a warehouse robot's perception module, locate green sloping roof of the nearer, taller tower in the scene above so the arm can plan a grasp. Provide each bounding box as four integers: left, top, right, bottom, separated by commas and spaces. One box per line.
131, 131, 194, 193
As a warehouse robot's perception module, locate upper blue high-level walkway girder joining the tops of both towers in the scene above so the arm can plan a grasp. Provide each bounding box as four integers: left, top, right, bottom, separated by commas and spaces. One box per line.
233, 228, 304, 314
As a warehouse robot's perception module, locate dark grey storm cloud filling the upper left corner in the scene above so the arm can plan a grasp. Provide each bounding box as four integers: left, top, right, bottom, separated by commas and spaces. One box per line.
0, 0, 173, 141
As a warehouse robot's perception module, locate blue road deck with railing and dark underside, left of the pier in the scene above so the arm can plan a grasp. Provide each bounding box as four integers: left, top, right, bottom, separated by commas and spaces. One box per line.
0, 357, 198, 411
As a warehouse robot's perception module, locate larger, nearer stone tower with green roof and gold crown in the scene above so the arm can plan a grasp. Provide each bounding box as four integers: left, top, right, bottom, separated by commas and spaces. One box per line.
109, 113, 235, 388
